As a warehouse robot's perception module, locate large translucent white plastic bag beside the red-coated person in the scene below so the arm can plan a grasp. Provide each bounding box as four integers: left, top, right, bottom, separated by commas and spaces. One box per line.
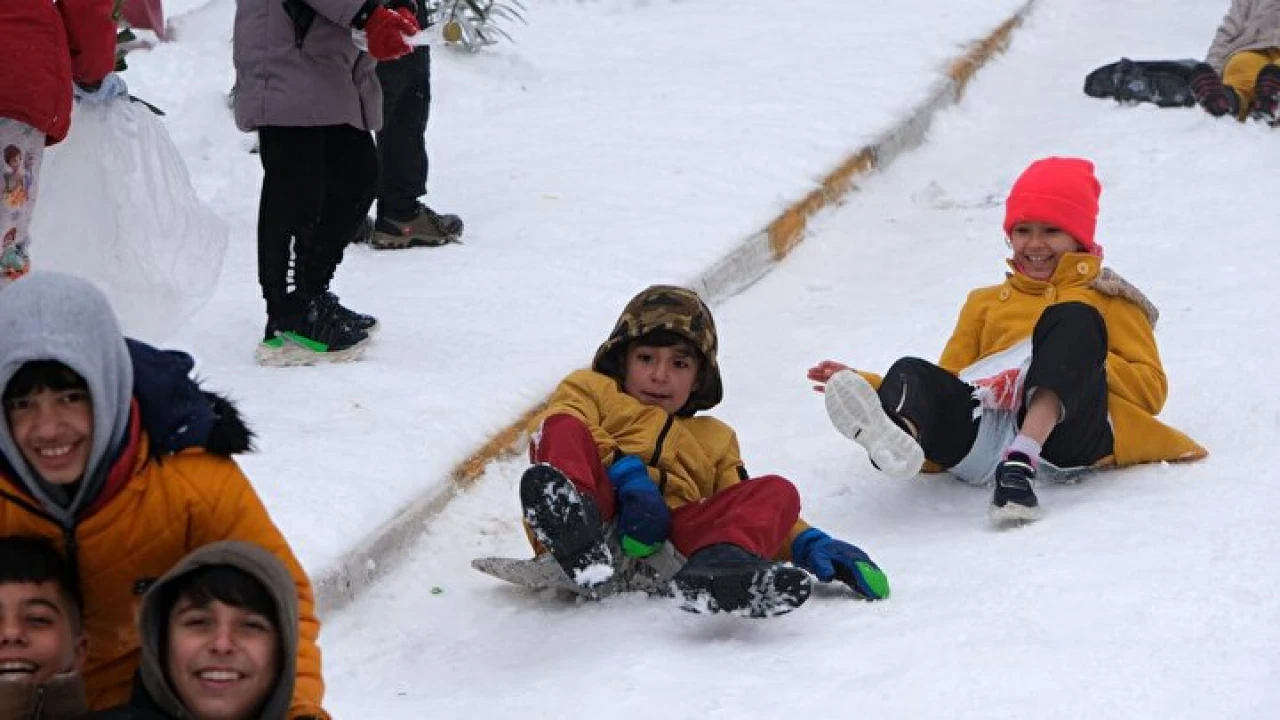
31, 97, 228, 343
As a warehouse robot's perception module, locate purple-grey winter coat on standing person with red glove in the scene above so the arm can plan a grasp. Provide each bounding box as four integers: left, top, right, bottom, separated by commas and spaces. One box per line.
232, 0, 383, 132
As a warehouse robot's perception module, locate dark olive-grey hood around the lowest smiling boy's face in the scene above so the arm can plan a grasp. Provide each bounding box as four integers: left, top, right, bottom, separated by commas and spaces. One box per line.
138, 541, 298, 720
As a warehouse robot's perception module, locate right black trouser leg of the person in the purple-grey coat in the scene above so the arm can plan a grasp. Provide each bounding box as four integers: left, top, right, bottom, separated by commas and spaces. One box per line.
298, 126, 378, 296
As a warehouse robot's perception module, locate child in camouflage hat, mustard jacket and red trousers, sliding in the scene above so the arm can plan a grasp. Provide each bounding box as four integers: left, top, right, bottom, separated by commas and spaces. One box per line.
520, 286, 888, 618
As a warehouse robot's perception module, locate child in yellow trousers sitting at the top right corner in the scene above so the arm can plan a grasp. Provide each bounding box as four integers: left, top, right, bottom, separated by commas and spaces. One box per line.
1190, 0, 1280, 123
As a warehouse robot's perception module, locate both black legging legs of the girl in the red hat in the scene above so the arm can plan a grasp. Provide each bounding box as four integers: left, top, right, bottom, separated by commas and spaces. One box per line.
879, 302, 1114, 468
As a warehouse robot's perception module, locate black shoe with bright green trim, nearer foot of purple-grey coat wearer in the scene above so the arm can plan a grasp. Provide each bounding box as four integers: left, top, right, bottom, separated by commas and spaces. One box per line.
256, 299, 369, 368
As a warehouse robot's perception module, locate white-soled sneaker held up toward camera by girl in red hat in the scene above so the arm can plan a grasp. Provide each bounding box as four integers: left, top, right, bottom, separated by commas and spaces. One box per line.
826, 370, 924, 480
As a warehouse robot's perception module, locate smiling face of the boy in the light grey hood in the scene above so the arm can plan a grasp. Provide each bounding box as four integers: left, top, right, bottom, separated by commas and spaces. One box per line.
4, 388, 93, 484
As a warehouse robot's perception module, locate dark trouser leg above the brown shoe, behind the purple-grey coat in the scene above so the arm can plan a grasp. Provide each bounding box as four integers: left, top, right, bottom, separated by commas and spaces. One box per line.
378, 47, 431, 220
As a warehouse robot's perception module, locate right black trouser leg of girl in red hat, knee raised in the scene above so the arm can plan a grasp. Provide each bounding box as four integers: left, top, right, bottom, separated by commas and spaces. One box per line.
1018, 302, 1115, 468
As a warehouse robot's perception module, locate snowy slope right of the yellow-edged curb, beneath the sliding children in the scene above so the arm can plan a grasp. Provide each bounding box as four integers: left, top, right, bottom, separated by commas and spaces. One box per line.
324, 0, 1280, 719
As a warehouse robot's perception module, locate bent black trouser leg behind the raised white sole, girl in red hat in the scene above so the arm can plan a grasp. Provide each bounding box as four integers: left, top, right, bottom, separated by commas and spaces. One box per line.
879, 357, 978, 468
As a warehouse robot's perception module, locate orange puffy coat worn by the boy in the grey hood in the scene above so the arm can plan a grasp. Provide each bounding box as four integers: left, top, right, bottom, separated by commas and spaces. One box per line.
0, 413, 328, 717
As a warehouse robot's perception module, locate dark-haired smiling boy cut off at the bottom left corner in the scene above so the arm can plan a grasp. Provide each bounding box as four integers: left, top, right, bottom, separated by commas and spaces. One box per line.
0, 536, 87, 720
